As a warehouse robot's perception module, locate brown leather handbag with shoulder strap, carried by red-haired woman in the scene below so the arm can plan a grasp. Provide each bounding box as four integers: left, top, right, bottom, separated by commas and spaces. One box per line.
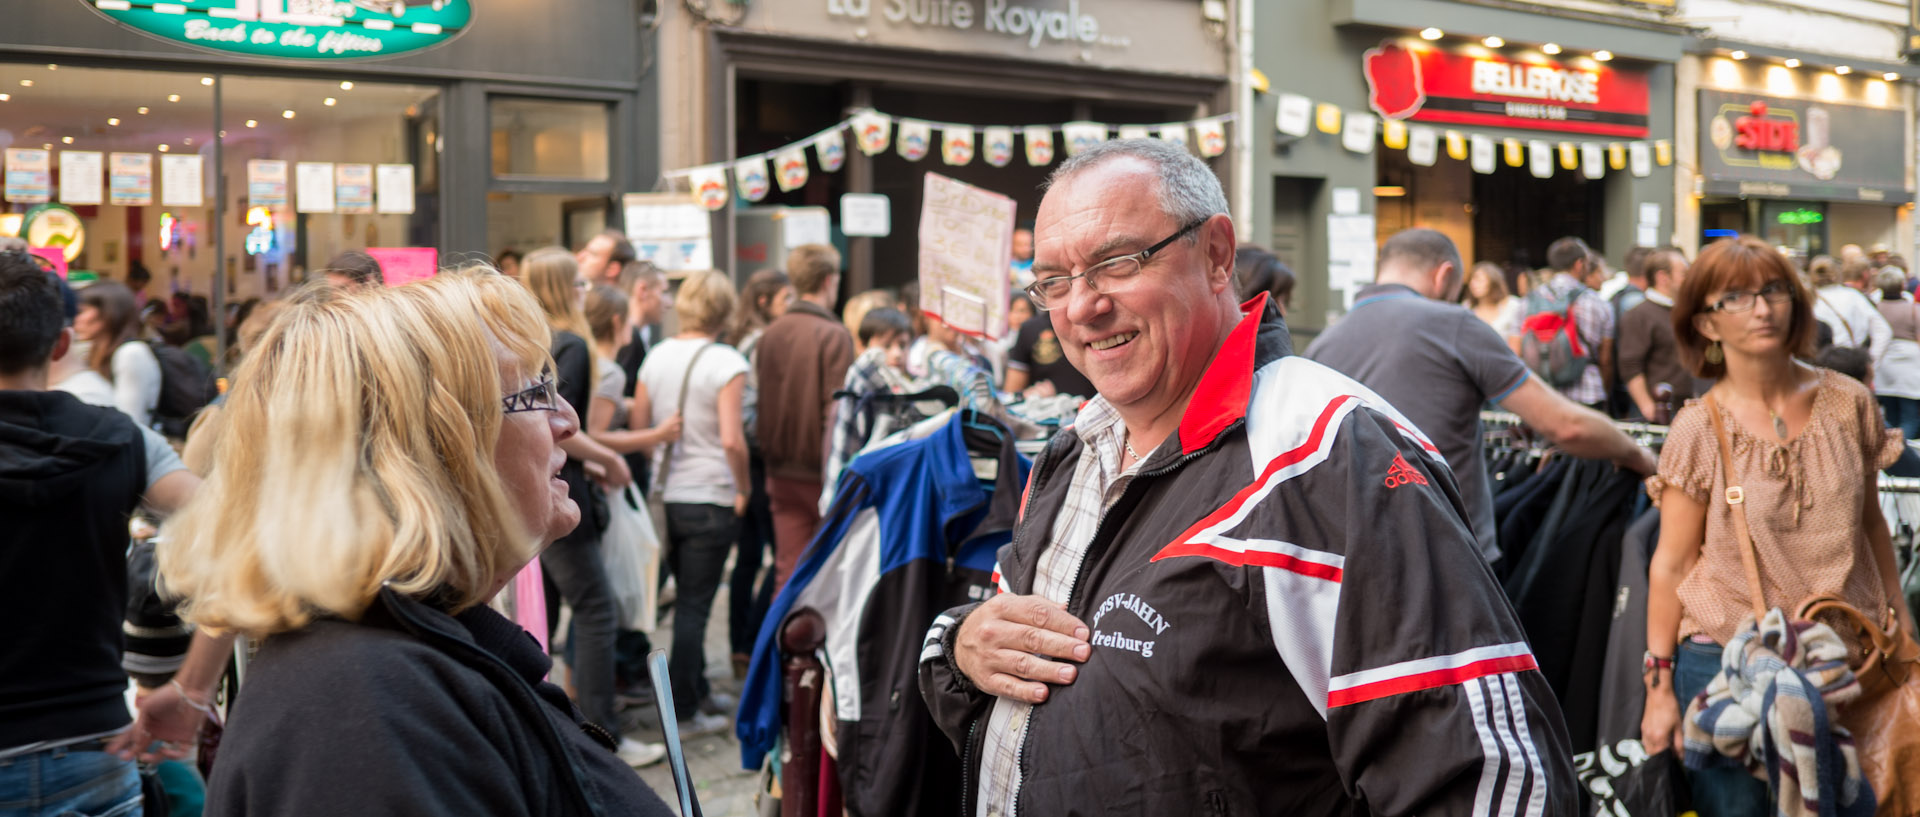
1705, 393, 1920, 817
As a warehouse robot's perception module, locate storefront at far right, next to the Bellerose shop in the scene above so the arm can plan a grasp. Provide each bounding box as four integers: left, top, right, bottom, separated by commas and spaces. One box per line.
1680, 48, 1914, 261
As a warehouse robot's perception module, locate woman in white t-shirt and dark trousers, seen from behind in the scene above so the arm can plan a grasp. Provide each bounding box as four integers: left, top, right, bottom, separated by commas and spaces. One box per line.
634, 270, 749, 729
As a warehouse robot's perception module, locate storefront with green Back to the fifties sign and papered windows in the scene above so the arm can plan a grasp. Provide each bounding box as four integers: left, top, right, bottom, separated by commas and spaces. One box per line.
0, 0, 659, 309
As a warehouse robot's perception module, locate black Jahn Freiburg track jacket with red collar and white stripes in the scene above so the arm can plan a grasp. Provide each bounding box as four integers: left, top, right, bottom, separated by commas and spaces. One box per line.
920, 297, 1578, 817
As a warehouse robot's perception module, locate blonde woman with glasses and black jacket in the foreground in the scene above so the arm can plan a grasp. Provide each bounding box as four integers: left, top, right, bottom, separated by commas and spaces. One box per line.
159, 272, 670, 817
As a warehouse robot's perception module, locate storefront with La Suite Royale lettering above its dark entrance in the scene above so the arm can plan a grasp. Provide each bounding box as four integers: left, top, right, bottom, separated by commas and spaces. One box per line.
659, 0, 1233, 293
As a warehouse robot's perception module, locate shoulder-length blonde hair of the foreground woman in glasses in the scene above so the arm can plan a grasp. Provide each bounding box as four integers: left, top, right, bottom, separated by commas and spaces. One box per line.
159, 272, 551, 637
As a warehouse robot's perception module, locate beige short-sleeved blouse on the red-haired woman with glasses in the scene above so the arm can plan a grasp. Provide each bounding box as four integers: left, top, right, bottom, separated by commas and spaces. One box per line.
1647, 370, 1903, 644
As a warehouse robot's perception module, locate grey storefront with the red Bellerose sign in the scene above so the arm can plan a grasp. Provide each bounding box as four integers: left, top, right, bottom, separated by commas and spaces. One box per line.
1248, 0, 1686, 334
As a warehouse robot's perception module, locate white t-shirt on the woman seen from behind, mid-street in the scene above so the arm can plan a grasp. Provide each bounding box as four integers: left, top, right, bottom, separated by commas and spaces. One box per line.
636, 338, 747, 508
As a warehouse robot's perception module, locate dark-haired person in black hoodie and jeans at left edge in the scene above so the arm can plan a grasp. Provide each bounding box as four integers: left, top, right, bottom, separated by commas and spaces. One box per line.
0, 251, 200, 815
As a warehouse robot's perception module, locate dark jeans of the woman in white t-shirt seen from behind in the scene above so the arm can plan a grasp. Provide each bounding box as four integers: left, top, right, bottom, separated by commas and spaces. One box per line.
666, 502, 739, 717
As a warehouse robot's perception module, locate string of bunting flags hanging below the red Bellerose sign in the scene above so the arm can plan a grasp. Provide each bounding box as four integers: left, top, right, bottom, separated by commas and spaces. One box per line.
1275, 94, 1674, 178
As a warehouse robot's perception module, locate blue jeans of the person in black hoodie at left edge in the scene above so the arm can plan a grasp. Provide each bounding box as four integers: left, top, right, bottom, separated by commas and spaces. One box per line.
0, 740, 140, 817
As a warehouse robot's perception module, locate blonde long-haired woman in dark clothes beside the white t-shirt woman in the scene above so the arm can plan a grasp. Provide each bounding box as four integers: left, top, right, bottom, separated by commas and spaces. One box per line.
520, 247, 651, 747
